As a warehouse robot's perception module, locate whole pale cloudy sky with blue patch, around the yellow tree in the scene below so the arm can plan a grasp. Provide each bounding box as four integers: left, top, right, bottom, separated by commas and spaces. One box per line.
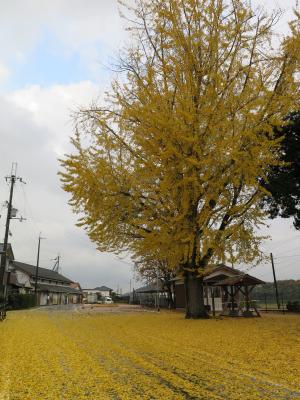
0, 0, 300, 291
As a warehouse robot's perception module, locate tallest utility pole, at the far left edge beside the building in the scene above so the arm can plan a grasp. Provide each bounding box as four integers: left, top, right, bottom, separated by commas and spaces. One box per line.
0, 163, 25, 308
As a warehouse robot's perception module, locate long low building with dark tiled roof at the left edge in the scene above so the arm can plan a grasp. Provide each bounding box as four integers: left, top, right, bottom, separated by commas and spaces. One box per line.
0, 244, 82, 305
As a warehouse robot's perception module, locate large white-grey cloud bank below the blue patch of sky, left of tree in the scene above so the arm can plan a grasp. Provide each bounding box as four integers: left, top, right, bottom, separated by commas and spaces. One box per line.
0, 82, 136, 290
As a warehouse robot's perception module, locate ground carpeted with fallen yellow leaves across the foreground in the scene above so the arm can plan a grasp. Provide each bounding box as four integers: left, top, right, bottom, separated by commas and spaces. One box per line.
0, 311, 300, 400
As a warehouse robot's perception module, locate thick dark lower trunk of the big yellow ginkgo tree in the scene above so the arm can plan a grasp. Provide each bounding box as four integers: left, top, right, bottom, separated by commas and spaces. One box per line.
184, 272, 209, 319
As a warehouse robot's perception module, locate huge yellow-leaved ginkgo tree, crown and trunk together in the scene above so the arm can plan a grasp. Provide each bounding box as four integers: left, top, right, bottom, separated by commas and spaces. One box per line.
61, 0, 300, 318
